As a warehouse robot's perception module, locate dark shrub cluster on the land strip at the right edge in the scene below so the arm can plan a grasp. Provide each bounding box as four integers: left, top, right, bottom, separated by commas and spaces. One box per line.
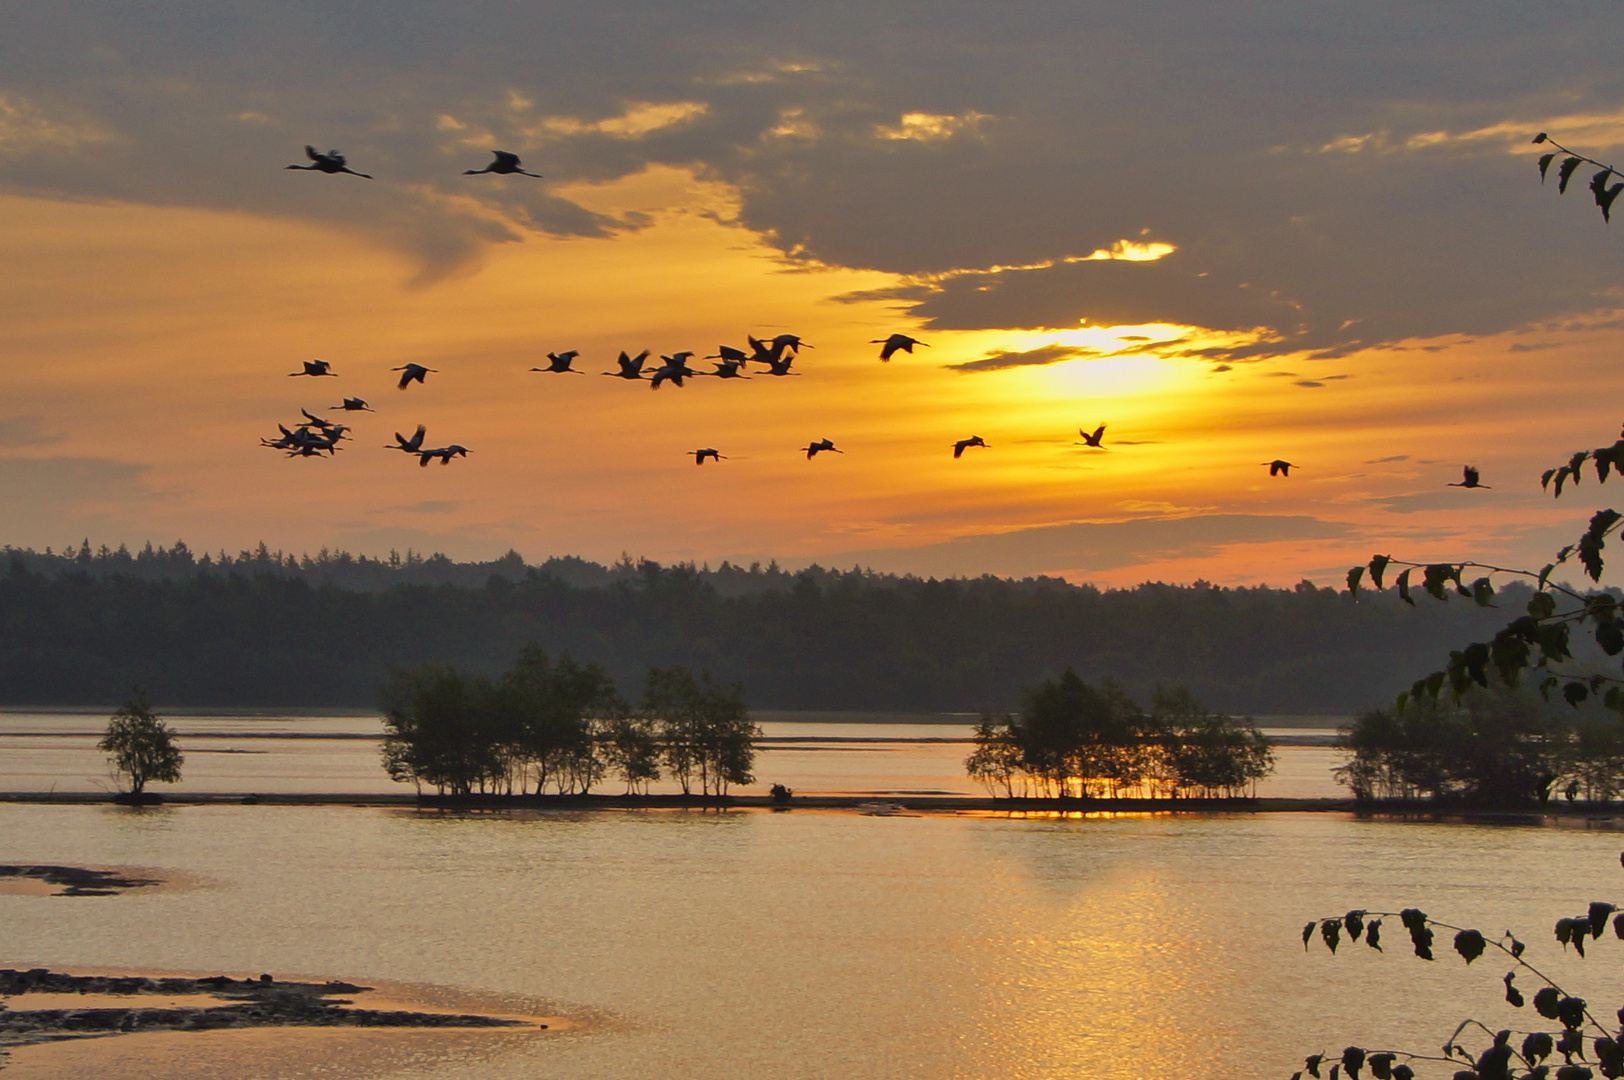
1337, 682, 1624, 807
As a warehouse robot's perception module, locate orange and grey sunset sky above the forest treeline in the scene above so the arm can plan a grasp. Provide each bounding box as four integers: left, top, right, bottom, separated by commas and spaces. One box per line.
0, 0, 1624, 585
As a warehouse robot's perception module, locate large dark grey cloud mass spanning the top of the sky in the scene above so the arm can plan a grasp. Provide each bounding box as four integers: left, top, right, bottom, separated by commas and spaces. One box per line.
0, 0, 1624, 341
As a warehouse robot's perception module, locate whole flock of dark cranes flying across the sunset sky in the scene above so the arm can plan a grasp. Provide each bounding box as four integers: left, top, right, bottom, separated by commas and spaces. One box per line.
260, 146, 1488, 489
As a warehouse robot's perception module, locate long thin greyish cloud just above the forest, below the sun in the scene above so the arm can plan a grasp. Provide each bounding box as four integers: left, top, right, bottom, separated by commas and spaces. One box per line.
805, 513, 1350, 577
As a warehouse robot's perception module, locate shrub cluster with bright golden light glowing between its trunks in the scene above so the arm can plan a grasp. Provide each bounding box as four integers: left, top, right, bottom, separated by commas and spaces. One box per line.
965, 669, 1275, 799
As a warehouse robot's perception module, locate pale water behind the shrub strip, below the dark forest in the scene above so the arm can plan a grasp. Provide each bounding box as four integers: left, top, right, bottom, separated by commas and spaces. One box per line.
0, 711, 1346, 797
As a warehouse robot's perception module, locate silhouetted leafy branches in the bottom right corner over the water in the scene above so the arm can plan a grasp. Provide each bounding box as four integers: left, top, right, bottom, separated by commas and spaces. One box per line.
1291, 901, 1624, 1080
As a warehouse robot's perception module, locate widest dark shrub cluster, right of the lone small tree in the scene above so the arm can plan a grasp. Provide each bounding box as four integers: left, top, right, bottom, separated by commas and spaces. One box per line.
382, 646, 760, 796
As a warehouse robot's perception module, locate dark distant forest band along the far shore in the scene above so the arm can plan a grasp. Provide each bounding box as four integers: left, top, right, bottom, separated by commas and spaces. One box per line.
0, 542, 1528, 715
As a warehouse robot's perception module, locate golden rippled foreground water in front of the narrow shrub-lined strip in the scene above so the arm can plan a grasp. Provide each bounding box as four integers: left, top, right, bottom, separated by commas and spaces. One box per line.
9, 804, 1624, 1080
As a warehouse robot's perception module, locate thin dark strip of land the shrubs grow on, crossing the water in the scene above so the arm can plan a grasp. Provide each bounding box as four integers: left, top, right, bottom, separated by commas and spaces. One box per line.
0, 791, 1624, 828
